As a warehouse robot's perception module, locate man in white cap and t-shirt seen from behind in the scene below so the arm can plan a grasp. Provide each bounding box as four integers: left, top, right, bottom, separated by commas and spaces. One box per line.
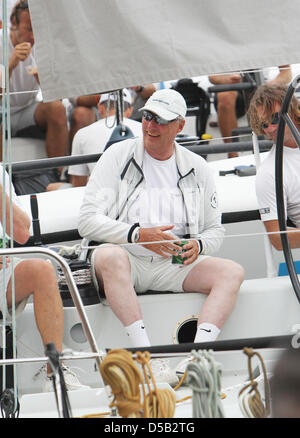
68, 88, 142, 187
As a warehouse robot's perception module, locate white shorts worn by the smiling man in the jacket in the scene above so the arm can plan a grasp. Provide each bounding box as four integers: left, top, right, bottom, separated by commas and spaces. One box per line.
91, 243, 209, 293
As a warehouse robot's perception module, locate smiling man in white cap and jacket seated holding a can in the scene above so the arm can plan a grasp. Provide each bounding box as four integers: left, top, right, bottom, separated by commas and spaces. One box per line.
79, 89, 244, 385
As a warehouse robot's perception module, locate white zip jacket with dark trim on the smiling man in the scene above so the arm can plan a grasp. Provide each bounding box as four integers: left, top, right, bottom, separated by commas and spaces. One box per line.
78, 138, 224, 254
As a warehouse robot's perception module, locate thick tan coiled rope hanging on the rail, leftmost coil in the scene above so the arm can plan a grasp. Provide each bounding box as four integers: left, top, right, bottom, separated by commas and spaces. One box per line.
100, 349, 176, 418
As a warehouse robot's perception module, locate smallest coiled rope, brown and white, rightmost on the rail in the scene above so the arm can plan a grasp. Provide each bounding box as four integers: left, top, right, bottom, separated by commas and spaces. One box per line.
239, 348, 270, 418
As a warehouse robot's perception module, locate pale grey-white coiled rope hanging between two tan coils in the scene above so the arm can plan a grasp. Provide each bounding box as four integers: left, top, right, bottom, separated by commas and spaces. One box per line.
185, 350, 225, 418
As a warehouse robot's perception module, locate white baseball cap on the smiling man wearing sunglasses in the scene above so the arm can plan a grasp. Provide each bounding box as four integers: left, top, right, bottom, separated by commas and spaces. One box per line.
140, 88, 187, 121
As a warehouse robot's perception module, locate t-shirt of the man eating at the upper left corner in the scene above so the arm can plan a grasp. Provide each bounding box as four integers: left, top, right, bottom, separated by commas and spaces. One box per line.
0, 30, 40, 113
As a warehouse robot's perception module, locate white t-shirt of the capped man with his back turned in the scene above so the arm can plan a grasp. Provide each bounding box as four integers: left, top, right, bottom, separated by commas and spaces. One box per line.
68, 116, 143, 176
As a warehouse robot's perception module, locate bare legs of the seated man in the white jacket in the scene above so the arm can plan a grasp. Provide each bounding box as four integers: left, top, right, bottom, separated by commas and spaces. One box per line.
95, 247, 245, 345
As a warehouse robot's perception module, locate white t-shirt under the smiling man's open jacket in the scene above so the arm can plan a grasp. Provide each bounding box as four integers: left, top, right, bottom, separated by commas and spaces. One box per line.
127, 151, 186, 256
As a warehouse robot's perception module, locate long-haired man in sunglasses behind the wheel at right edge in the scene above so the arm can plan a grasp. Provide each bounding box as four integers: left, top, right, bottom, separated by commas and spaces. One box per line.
248, 85, 300, 250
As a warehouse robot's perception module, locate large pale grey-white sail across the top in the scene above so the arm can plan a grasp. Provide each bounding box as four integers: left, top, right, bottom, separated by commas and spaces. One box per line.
29, 0, 300, 101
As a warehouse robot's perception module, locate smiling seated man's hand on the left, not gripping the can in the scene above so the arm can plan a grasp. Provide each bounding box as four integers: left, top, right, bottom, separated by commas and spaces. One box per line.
138, 225, 181, 259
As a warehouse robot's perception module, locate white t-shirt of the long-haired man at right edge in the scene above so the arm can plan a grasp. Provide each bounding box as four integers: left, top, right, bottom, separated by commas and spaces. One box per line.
256, 145, 300, 227
